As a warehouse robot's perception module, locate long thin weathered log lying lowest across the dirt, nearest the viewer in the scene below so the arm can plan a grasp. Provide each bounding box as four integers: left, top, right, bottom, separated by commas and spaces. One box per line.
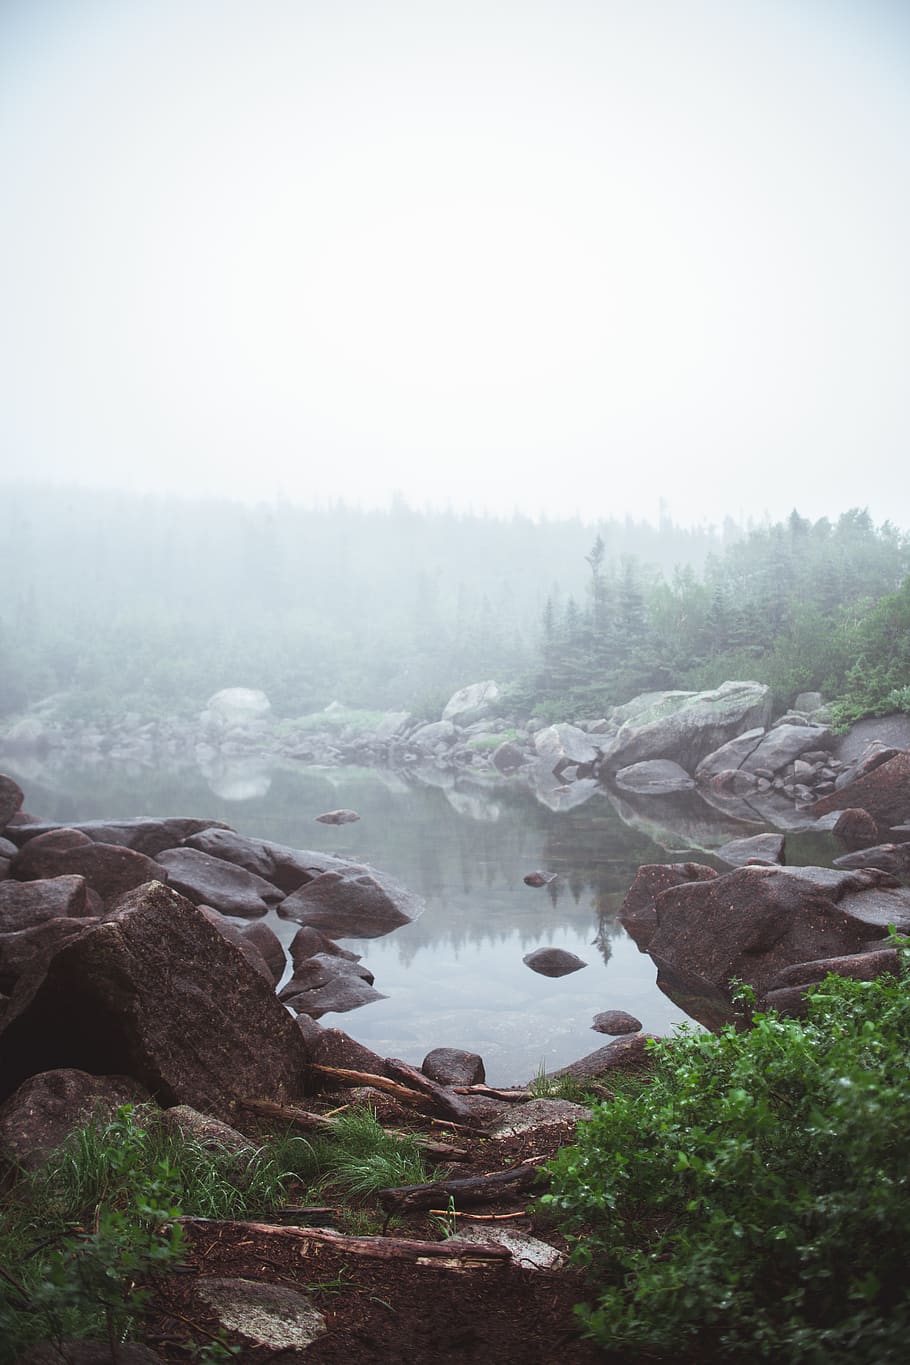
177, 1218, 512, 1272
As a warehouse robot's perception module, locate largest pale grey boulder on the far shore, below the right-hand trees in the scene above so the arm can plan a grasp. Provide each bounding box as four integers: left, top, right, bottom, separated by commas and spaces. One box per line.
603, 683, 771, 773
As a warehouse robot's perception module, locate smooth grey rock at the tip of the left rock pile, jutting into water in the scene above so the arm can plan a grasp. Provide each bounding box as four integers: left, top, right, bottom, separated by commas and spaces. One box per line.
278, 865, 423, 938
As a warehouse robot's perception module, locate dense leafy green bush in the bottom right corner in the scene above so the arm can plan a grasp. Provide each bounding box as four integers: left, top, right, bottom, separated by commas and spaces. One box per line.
543, 975, 910, 1365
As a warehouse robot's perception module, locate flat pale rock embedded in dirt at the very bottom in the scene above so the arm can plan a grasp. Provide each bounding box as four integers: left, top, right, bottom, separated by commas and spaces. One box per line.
192, 1275, 326, 1355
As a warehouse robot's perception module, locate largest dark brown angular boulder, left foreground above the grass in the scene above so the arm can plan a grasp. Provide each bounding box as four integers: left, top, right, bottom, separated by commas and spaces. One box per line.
0, 882, 307, 1122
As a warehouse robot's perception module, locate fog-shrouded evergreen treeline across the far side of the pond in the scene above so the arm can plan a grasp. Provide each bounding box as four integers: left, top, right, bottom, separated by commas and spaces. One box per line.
0, 486, 910, 723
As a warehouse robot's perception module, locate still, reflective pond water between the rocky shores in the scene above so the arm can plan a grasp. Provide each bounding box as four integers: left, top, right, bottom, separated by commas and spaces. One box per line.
3, 759, 840, 1085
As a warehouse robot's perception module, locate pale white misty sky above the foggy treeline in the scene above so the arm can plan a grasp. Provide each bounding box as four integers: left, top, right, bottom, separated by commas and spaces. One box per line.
0, 0, 910, 528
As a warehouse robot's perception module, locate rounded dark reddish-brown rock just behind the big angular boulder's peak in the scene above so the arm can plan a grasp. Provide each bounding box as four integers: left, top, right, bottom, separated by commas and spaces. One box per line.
11, 829, 168, 901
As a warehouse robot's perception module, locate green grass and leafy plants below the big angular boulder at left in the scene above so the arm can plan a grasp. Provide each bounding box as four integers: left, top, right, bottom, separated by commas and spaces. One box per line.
0, 1104, 427, 1365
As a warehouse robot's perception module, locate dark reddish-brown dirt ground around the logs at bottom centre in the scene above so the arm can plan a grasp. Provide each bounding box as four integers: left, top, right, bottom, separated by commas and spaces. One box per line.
145, 1099, 629, 1365
